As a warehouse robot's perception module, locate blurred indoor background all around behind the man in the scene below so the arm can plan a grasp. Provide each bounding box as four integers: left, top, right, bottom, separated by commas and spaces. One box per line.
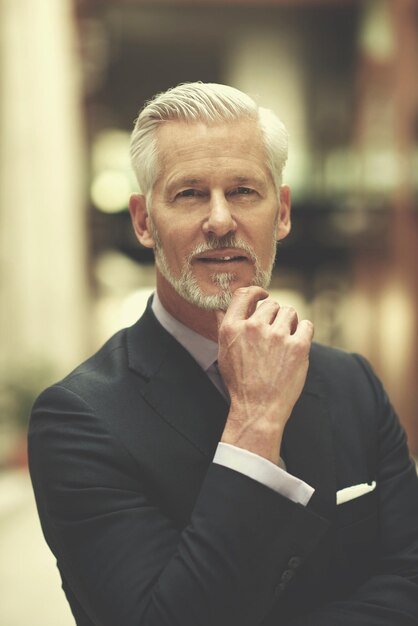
0, 0, 418, 626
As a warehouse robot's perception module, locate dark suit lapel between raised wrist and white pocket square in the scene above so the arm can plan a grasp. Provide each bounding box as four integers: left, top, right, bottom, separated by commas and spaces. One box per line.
282, 367, 336, 519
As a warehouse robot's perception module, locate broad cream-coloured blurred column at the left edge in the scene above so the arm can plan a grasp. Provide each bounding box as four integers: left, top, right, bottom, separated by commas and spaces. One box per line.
0, 0, 89, 376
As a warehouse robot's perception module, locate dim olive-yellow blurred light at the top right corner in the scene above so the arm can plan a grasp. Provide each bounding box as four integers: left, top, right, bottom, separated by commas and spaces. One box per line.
359, 0, 395, 62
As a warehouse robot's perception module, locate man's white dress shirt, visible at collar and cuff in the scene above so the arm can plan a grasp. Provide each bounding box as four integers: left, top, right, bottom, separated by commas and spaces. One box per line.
152, 293, 314, 506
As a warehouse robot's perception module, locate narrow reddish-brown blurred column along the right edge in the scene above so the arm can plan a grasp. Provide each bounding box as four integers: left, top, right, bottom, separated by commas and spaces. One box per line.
391, 0, 418, 454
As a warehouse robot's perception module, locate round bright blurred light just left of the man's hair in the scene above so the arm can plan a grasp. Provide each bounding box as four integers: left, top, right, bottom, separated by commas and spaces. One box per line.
90, 170, 132, 213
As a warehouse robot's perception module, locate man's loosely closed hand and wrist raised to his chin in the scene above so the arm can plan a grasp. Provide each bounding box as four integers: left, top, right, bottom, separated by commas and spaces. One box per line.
217, 287, 313, 464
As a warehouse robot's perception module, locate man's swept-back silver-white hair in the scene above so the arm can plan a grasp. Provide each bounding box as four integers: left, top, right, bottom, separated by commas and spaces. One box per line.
130, 82, 288, 204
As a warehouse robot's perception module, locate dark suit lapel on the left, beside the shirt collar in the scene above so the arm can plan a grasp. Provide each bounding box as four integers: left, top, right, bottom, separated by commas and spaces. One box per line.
128, 306, 229, 458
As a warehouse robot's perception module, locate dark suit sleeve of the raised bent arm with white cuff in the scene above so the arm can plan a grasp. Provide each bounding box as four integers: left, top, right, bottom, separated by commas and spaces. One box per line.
29, 386, 334, 626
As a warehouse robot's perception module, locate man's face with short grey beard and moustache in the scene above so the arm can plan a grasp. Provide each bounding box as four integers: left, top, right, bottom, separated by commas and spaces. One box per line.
134, 120, 289, 309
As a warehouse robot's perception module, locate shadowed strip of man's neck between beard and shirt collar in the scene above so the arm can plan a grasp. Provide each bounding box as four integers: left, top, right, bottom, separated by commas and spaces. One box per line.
157, 271, 218, 341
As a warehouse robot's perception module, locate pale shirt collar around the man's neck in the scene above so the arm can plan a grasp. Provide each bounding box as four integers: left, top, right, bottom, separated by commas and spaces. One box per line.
152, 292, 218, 371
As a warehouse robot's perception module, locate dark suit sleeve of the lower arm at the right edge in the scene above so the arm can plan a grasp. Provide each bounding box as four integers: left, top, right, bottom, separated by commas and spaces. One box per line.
288, 355, 418, 626
